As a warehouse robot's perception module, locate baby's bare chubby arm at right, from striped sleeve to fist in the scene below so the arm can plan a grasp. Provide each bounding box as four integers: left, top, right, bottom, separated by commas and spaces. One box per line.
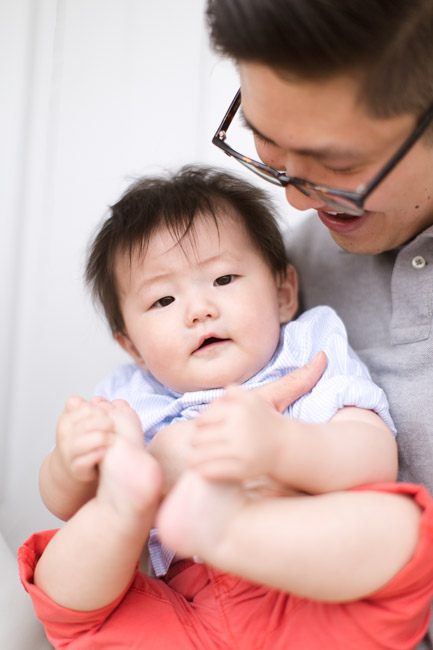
189, 388, 397, 494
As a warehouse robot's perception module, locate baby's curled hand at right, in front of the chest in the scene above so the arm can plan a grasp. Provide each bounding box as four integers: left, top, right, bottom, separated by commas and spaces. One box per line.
190, 388, 284, 481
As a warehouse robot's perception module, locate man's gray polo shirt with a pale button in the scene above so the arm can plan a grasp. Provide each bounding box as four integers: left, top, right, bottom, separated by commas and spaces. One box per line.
286, 214, 433, 648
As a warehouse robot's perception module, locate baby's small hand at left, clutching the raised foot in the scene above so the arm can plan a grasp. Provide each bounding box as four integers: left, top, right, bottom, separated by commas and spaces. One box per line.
56, 396, 115, 482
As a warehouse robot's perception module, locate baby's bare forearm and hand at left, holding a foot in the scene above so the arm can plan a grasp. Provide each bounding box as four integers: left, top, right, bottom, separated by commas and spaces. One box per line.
39, 396, 115, 521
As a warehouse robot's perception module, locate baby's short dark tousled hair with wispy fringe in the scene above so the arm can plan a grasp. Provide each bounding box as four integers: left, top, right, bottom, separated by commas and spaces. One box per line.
85, 166, 287, 334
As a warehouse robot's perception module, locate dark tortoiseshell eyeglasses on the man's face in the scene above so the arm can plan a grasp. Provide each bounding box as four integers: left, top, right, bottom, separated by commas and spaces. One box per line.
212, 89, 433, 216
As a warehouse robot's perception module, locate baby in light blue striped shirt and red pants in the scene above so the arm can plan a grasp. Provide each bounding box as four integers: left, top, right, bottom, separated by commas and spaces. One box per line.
20, 168, 433, 650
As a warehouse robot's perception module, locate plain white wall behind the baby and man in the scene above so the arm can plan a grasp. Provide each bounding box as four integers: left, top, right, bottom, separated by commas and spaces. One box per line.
0, 0, 300, 549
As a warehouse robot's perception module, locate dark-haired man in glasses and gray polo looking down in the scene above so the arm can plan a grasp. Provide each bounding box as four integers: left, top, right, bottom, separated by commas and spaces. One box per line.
207, 0, 433, 648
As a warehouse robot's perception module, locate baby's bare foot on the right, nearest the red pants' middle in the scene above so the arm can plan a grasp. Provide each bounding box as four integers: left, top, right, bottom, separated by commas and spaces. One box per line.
156, 471, 244, 563
